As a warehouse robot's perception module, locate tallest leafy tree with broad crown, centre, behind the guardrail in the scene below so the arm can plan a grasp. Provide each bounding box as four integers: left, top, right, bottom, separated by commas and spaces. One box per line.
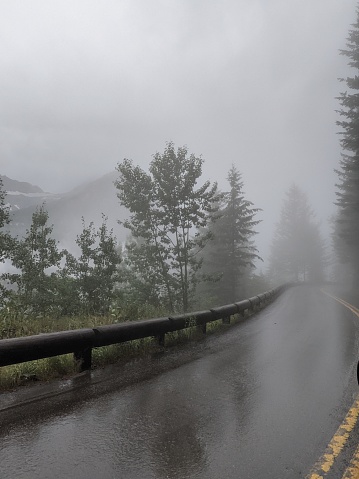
116, 142, 218, 311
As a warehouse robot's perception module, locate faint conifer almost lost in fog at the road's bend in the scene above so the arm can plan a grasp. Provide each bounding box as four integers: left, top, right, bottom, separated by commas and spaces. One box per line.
268, 184, 325, 283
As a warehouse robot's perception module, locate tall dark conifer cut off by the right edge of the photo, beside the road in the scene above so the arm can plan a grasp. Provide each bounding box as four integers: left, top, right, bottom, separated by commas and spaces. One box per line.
335, 8, 359, 289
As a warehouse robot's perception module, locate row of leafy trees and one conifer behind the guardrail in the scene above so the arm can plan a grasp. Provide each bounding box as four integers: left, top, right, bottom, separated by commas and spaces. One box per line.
0, 142, 259, 315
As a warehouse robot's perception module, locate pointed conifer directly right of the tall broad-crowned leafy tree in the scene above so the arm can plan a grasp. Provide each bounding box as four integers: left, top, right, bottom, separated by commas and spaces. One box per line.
203, 166, 261, 304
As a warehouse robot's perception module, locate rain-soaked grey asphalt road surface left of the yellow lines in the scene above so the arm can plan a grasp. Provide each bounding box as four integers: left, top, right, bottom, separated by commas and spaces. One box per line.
0, 286, 357, 479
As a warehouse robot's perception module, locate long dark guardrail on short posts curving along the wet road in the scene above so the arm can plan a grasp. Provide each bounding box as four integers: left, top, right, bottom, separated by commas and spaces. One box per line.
0, 285, 288, 371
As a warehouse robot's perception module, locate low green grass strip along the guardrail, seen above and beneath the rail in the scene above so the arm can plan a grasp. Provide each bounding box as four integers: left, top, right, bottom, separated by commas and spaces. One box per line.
0, 312, 253, 391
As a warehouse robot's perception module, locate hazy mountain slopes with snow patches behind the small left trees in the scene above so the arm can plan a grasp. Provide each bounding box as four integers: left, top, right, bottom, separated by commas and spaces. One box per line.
2, 171, 128, 252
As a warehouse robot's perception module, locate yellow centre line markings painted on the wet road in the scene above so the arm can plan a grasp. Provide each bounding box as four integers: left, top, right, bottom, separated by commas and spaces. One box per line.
307, 289, 359, 479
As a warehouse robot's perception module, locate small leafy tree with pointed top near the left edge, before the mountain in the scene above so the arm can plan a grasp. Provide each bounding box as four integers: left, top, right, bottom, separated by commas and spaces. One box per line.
6, 205, 64, 313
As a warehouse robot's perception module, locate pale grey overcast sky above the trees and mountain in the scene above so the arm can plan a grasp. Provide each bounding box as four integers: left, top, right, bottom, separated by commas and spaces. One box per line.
0, 0, 358, 260
